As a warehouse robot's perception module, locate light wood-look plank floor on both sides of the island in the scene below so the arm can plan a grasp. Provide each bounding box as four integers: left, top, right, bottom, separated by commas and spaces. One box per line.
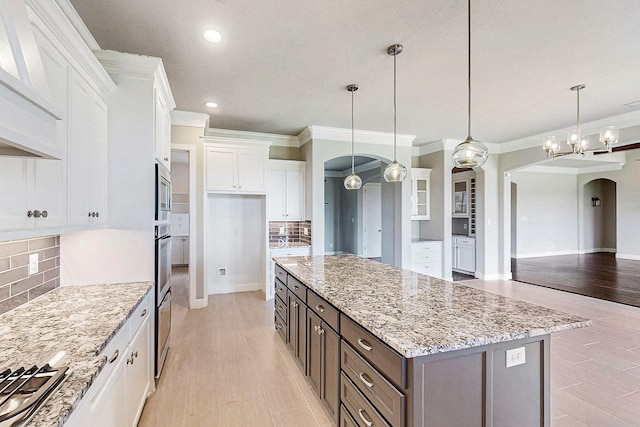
139, 270, 640, 427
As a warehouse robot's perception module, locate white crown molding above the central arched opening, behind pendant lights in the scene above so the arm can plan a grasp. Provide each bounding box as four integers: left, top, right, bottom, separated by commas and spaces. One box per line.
298, 125, 416, 147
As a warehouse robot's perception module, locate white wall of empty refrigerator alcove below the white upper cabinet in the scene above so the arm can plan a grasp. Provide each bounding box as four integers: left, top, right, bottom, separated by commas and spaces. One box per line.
206, 194, 266, 294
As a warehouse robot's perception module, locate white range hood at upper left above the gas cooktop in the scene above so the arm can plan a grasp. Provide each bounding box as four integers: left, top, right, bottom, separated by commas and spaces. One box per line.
0, 0, 64, 159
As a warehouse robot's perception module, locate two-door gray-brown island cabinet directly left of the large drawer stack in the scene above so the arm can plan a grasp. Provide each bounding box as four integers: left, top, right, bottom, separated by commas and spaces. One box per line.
307, 309, 340, 423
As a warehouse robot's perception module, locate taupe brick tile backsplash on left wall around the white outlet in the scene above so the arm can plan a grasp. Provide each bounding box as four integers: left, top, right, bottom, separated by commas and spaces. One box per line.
0, 236, 60, 314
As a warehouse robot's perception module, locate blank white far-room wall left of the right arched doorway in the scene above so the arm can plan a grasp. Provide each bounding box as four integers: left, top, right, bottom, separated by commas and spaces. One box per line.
511, 172, 578, 258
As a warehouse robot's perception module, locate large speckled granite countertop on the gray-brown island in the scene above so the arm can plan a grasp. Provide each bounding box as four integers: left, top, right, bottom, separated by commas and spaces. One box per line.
275, 255, 591, 358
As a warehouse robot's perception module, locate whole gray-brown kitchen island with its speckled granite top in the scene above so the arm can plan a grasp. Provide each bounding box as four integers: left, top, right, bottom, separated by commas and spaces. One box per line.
274, 255, 591, 427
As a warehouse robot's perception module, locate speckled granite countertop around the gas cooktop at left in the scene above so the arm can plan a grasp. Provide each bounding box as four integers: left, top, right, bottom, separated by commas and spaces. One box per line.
0, 282, 152, 427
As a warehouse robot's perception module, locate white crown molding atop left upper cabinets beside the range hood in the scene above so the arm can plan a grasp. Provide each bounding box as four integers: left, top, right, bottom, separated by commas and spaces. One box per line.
26, 0, 116, 93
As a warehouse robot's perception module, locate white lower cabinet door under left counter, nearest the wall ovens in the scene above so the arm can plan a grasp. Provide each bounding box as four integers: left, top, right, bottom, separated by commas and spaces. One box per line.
124, 316, 153, 427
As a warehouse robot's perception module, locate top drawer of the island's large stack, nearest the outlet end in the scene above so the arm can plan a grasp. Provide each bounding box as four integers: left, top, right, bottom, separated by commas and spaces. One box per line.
340, 314, 407, 389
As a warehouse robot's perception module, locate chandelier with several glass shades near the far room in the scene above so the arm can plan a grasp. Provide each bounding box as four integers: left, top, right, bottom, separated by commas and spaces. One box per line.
542, 84, 619, 159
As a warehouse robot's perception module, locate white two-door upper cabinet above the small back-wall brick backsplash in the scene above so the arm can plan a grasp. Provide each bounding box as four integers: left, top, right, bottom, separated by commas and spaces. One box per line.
267, 160, 306, 221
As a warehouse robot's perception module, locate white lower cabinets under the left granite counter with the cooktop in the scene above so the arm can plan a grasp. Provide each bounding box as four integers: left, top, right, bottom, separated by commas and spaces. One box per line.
65, 294, 153, 427
